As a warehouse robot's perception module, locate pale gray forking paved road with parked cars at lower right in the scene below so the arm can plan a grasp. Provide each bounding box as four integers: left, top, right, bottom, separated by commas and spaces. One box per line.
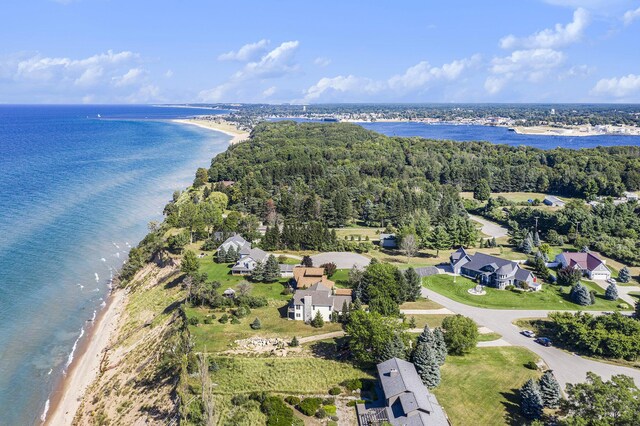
422, 288, 640, 387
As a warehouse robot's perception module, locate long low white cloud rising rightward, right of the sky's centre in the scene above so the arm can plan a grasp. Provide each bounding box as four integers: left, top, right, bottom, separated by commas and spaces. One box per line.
296, 55, 480, 103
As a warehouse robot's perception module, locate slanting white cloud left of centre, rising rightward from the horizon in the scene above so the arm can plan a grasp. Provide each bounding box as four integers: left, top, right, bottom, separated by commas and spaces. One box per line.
199, 40, 300, 102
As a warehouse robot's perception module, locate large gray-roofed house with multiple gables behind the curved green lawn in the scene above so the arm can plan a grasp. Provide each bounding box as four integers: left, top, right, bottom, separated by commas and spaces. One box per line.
449, 247, 542, 291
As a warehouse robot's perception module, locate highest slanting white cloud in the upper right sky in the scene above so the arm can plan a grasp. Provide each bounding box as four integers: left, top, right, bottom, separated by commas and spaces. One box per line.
500, 8, 590, 49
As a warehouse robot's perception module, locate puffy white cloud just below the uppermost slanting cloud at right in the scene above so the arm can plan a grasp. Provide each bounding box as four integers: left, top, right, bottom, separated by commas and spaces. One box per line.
484, 49, 565, 94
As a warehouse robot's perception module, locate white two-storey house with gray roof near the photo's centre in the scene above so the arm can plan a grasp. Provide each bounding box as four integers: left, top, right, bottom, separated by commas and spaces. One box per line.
288, 282, 351, 322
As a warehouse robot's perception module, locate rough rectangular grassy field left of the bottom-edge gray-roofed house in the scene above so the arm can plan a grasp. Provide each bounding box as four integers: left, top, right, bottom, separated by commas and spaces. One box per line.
211, 357, 372, 395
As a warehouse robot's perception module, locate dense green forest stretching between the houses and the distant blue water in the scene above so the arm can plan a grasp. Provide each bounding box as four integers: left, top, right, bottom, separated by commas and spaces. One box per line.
208, 121, 640, 216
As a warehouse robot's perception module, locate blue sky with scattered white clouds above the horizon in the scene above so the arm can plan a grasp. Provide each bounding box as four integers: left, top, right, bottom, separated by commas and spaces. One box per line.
0, 0, 640, 103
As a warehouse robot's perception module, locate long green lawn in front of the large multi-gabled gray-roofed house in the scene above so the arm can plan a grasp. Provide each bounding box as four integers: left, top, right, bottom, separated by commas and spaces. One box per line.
423, 275, 623, 311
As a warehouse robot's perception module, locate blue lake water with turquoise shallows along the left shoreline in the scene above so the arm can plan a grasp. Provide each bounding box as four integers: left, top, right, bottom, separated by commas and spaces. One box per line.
0, 106, 230, 425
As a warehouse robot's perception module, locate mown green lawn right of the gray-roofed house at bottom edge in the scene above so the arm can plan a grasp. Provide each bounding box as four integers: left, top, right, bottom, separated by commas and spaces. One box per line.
434, 347, 539, 425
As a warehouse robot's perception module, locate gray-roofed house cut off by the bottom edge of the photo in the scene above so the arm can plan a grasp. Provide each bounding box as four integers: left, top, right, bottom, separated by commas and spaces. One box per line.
358, 358, 450, 426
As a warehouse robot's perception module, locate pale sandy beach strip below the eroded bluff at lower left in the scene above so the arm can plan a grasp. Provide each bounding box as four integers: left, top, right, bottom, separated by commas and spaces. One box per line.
44, 290, 126, 426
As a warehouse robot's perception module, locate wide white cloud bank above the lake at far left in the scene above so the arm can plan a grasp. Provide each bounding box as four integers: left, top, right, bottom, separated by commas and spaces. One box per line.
0, 50, 159, 102
